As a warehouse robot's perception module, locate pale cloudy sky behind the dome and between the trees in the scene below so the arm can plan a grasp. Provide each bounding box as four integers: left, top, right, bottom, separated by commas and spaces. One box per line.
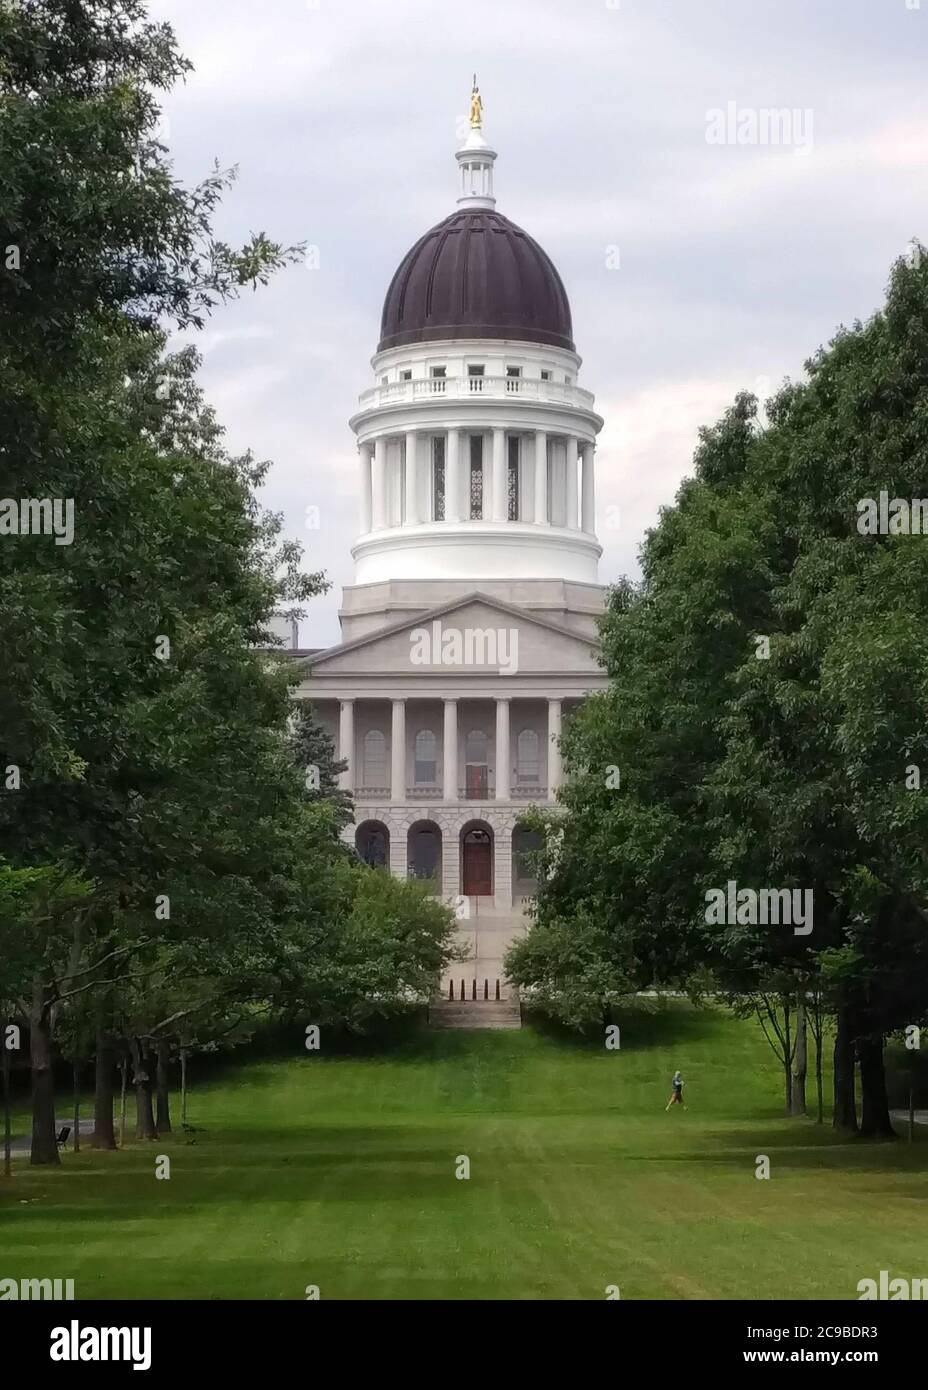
150, 0, 928, 646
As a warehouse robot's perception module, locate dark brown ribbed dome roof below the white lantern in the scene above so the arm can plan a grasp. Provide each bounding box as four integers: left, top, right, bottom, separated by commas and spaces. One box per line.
378, 209, 574, 352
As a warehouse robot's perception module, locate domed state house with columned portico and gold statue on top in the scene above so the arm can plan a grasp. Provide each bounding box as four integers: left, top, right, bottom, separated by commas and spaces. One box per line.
297, 89, 607, 994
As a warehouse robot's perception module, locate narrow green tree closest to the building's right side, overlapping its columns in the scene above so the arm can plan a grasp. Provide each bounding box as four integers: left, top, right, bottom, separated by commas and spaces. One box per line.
515, 396, 771, 1006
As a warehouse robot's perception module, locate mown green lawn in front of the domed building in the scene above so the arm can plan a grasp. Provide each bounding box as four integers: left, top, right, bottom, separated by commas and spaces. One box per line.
0, 1004, 928, 1300
